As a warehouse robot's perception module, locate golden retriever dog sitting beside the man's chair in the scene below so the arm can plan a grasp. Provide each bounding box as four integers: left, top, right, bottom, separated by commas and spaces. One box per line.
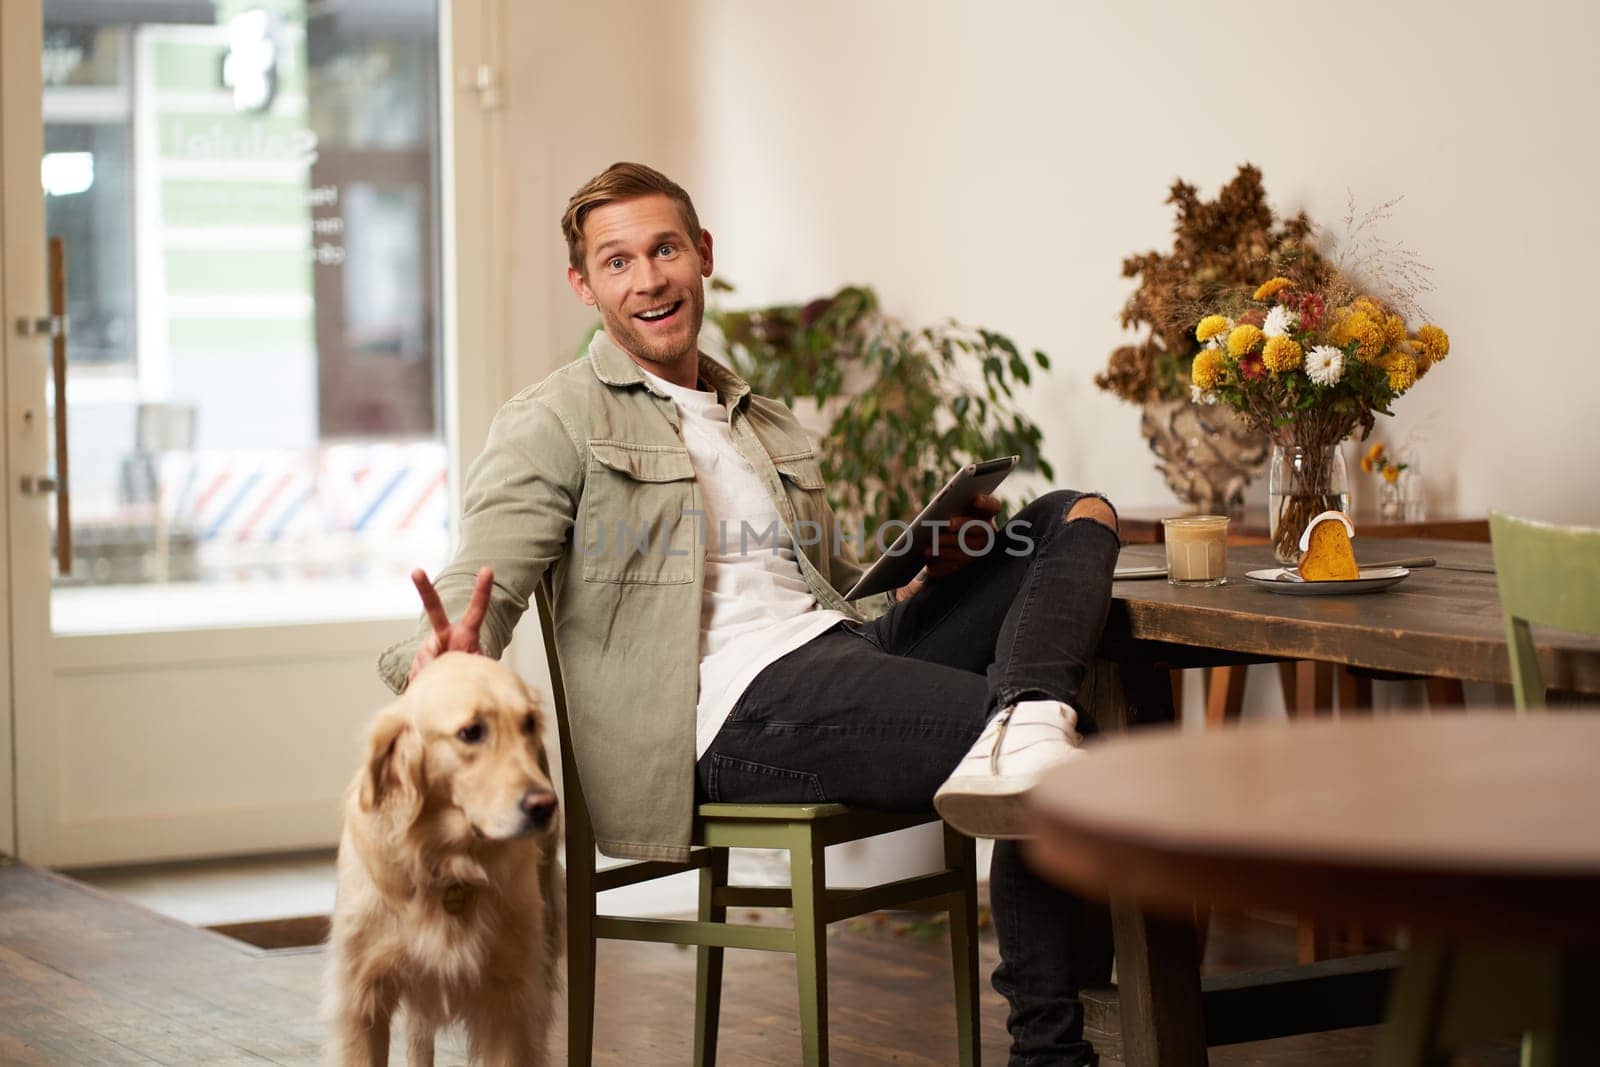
325, 653, 565, 1067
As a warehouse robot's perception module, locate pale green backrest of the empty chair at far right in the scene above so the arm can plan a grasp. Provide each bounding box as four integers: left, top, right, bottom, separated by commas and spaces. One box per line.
1490, 512, 1600, 709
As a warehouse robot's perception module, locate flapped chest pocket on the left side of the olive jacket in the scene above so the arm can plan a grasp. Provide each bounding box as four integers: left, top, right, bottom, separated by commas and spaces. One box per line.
574, 442, 698, 585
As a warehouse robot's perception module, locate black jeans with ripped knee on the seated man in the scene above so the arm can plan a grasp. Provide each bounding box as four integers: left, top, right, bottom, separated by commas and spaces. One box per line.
696, 491, 1118, 1067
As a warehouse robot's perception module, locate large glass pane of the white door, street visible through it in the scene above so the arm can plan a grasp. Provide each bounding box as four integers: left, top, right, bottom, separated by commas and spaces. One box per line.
40, 0, 448, 633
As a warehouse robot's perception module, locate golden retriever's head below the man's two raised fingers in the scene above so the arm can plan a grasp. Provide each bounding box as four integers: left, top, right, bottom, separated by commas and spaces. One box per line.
358, 653, 558, 840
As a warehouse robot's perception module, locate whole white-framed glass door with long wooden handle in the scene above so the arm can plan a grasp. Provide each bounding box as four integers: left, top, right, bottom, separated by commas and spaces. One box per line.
0, 0, 473, 865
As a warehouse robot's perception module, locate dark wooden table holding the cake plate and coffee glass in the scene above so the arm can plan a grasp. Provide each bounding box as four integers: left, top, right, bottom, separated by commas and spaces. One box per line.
1049, 537, 1600, 1067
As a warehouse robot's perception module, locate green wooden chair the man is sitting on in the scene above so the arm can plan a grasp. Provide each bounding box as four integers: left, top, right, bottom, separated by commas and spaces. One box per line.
536, 585, 978, 1067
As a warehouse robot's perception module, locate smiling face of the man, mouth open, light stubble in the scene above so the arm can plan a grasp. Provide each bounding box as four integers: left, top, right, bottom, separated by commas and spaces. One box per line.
566, 194, 710, 365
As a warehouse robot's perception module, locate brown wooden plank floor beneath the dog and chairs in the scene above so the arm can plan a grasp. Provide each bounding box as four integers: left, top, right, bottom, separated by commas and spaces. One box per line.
0, 859, 1517, 1067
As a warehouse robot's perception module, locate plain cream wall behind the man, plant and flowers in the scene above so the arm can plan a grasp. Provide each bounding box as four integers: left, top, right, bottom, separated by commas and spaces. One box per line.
509, 0, 1600, 523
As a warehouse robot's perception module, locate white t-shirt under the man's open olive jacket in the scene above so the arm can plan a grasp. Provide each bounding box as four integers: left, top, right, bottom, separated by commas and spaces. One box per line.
642, 371, 848, 760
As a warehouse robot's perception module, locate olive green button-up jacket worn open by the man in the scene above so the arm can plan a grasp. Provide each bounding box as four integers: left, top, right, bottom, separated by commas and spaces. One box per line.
378, 331, 890, 861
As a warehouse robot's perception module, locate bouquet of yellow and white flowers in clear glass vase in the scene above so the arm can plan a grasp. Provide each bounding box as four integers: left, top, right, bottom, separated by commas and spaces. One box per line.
1190, 274, 1450, 560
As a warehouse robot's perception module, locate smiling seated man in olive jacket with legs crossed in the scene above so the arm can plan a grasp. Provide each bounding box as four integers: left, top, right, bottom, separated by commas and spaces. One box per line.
381, 163, 1117, 1067
